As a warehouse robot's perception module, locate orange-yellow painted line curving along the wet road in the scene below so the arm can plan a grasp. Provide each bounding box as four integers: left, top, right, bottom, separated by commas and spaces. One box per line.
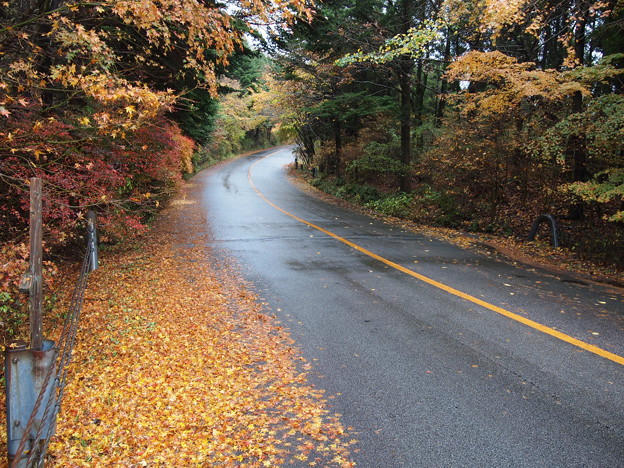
247, 149, 624, 365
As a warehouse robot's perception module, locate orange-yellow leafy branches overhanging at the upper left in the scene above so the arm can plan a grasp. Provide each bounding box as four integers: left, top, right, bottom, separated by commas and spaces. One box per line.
0, 0, 309, 141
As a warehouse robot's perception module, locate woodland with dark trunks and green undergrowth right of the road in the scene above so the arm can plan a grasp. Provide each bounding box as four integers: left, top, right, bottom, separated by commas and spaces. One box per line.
280, 0, 624, 267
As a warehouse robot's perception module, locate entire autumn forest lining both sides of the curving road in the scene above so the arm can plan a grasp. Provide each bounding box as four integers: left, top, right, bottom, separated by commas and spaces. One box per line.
0, 0, 624, 340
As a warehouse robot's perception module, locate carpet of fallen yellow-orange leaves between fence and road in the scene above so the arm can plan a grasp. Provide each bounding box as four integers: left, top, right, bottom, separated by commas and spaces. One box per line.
36, 179, 355, 467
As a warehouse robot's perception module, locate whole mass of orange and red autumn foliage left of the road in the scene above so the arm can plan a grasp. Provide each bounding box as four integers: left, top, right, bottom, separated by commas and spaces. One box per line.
0, 0, 306, 342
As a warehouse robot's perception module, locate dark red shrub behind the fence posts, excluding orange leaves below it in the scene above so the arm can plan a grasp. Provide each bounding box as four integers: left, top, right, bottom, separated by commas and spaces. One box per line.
0, 113, 195, 247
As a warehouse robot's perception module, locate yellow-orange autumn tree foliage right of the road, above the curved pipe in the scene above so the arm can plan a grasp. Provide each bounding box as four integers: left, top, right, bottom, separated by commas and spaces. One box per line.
421, 2, 622, 260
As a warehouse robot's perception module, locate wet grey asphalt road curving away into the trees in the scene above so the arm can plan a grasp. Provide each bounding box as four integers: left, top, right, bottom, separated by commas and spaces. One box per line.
196, 148, 624, 468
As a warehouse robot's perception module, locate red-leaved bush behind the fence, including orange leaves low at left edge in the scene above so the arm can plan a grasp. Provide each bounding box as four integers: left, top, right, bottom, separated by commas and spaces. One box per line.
0, 107, 195, 342
